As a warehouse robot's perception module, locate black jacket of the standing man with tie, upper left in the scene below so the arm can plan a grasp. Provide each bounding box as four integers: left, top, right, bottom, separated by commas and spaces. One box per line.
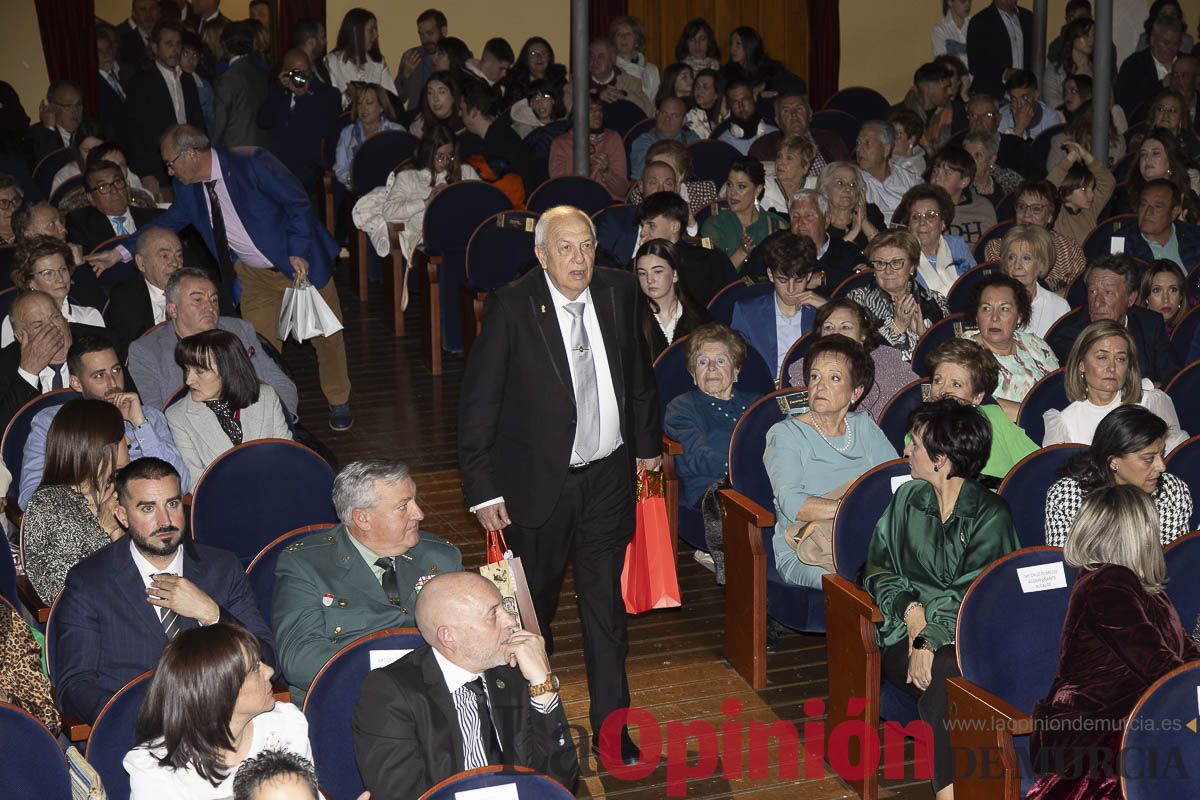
125, 64, 204, 182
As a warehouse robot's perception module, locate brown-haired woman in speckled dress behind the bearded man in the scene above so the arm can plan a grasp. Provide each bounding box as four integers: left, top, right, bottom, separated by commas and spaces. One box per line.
20, 397, 130, 606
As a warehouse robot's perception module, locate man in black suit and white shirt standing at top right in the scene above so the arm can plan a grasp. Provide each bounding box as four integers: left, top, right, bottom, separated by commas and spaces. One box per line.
967, 0, 1033, 97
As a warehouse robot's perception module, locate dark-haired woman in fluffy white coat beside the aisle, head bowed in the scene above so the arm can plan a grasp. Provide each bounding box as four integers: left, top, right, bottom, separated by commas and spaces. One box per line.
353, 124, 479, 263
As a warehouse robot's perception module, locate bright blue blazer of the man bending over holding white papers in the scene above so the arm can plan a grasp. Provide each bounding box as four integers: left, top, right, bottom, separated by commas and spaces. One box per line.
125, 148, 338, 289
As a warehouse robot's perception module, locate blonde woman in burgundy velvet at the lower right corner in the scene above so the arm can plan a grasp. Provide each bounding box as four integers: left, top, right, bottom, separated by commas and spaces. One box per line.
1025, 486, 1200, 800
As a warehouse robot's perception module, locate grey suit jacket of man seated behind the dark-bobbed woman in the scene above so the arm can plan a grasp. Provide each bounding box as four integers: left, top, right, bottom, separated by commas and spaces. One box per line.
128, 317, 300, 417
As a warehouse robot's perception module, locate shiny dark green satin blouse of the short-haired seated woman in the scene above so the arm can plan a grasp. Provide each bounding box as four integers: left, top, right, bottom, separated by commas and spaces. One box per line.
863, 481, 1021, 650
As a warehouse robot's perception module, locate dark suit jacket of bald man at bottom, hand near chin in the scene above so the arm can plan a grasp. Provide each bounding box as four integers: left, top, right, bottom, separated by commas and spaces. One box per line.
350, 646, 578, 800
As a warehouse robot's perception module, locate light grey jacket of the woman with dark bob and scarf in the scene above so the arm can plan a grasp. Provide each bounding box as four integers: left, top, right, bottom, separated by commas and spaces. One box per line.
167, 385, 292, 492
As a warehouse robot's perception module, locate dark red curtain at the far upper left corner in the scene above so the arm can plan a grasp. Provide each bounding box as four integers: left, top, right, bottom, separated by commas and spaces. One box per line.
30, 0, 100, 119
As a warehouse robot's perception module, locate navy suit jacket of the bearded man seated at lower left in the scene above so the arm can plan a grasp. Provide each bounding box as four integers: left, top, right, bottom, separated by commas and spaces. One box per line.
52, 536, 275, 722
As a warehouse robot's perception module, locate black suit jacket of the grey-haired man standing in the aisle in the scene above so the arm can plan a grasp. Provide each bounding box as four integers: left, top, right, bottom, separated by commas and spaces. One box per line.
458, 267, 662, 528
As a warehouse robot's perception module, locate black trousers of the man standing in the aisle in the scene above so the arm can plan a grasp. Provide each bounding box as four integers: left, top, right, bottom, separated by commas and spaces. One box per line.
504, 445, 635, 735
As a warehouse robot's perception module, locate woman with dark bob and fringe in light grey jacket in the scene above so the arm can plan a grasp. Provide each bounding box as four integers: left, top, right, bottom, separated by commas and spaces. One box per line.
167, 329, 292, 492
